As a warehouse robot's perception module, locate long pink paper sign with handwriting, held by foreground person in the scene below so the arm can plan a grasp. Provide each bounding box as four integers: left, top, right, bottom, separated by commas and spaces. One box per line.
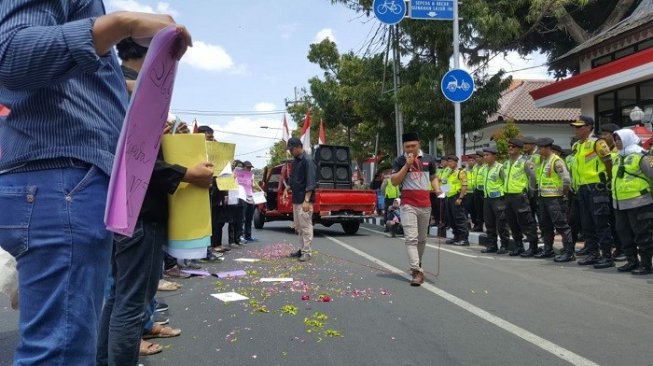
104, 26, 178, 237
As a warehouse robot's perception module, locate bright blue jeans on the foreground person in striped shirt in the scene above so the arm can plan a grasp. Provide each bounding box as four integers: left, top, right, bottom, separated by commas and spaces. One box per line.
0, 165, 113, 366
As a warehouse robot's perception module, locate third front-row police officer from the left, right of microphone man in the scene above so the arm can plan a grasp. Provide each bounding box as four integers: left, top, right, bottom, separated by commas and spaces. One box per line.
504, 138, 537, 257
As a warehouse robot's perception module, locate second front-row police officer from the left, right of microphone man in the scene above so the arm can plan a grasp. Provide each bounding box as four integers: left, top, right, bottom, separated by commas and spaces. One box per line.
481, 147, 510, 254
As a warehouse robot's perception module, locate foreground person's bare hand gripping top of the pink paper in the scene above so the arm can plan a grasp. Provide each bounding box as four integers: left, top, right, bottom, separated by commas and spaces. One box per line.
125, 12, 193, 60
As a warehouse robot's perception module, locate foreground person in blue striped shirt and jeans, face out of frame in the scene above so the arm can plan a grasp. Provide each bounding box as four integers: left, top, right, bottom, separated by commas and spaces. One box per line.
0, 4, 191, 365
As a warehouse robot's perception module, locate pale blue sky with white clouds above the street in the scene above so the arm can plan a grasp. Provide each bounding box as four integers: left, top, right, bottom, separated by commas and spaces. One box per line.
104, 0, 546, 167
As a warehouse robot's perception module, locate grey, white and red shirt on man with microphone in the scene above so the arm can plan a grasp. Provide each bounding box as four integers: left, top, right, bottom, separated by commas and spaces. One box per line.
392, 151, 435, 207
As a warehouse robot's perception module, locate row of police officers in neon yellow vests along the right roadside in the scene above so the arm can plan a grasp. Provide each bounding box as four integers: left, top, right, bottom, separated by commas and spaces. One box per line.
431, 116, 653, 275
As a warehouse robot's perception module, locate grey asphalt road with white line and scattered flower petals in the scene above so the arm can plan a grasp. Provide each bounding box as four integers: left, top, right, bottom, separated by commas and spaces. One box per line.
0, 223, 653, 366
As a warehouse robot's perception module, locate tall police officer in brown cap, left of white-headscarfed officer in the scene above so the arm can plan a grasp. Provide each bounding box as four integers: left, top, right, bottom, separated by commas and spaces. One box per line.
571, 116, 614, 268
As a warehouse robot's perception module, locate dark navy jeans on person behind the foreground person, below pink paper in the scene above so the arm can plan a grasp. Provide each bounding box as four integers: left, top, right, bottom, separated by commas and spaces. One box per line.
96, 221, 166, 366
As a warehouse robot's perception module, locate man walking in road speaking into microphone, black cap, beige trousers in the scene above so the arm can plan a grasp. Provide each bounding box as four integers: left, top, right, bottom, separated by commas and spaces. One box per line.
391, 132, 442, 286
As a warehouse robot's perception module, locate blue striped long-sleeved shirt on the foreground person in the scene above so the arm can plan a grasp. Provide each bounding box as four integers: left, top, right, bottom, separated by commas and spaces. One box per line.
0, 0, 128, 175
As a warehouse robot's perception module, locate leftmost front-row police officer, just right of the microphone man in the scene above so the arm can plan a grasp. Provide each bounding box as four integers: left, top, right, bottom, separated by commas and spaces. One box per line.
445, 155, 469, 246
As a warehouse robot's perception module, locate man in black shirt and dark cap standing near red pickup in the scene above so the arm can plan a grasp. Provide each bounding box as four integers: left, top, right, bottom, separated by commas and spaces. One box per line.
283, 137, 317, 262
